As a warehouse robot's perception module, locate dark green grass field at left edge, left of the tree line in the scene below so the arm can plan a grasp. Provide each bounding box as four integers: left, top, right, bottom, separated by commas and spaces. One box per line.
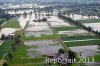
0, 40, 14, 59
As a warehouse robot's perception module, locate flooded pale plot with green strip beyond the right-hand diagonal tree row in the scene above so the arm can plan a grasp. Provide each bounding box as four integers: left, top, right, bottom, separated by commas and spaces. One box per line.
71, 14, 100, 31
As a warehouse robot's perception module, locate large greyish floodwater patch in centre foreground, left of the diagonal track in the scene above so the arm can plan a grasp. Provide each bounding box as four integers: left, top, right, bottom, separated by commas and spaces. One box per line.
24, 40, 62, 57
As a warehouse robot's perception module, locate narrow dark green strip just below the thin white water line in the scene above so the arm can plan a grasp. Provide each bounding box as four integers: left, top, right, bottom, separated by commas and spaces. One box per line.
64, 40, 100, 47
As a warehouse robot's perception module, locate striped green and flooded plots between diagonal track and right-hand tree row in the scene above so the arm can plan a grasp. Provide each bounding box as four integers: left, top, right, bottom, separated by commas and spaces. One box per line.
53, 14, 100, 66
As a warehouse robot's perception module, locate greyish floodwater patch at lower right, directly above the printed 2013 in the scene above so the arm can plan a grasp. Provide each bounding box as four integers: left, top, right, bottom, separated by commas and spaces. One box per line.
69, 45, 100, 57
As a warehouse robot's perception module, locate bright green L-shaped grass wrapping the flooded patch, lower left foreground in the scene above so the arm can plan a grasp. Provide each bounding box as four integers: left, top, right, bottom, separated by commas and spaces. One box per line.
9, 44, 44, 66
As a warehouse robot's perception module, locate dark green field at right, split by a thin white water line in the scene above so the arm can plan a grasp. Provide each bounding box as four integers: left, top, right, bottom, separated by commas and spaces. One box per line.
60, 32, 100, 47
